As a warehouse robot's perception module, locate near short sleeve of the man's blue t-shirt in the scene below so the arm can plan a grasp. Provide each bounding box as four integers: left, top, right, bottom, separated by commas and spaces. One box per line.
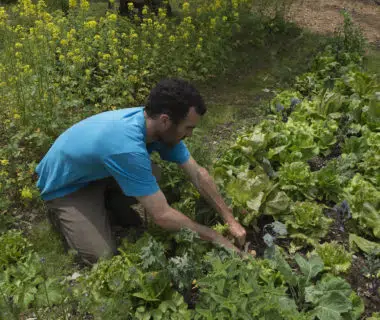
104, 152, 160, 197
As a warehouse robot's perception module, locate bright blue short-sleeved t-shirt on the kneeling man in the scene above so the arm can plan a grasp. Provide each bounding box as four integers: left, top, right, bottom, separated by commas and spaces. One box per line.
36, 107, 190, 200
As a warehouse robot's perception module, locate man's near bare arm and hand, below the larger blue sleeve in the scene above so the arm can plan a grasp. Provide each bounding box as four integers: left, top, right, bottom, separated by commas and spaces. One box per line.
137, 190, 240, 252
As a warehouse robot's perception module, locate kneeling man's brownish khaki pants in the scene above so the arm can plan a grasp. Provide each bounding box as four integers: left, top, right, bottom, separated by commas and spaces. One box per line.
46, 164, 160, 265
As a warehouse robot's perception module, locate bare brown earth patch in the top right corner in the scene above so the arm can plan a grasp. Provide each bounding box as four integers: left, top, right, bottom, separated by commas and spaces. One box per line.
287, 0, 380, 47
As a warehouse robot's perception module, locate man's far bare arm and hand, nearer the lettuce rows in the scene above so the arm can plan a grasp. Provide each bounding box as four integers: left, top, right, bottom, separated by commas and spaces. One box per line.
180, 157, 246, 245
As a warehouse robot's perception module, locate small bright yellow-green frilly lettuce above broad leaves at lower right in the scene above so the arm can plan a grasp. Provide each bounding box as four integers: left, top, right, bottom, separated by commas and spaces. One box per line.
315, 241, 352, 275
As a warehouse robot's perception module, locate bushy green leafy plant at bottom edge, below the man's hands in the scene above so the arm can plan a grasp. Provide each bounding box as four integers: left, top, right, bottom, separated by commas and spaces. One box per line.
194, 251, 305, 320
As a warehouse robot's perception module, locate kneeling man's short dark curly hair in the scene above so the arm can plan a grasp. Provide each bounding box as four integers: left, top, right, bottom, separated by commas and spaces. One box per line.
145, 78, 207, 124
